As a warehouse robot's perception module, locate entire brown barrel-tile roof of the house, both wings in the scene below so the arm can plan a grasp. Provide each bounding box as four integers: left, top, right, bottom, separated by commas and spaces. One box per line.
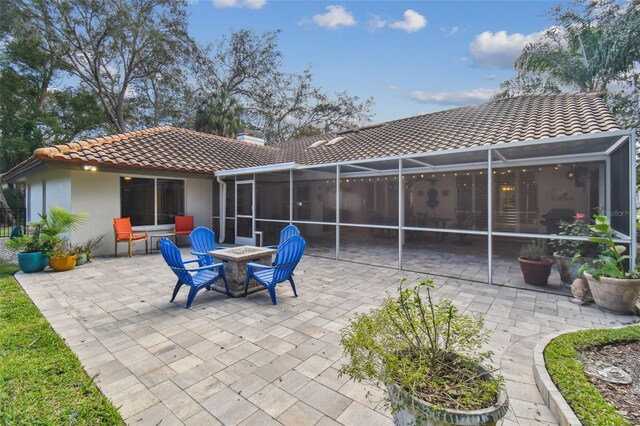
4, 93, 620, 179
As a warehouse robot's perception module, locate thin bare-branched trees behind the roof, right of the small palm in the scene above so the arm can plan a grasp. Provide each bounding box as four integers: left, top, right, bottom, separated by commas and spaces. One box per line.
200, 30, 373, 143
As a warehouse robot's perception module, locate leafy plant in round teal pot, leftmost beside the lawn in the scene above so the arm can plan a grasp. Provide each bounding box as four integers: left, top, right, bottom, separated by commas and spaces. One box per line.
7, 223, 58, 273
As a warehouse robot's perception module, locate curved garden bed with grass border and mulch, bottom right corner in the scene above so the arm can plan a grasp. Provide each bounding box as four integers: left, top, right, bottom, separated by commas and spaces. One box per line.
544, 325, 640, 425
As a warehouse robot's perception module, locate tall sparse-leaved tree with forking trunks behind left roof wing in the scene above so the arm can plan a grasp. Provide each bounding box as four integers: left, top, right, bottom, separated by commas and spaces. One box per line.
22, 0, 198, 132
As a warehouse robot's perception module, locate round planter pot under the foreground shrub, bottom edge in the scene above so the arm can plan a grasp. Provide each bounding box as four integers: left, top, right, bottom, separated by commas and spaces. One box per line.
387, 367, 509, 426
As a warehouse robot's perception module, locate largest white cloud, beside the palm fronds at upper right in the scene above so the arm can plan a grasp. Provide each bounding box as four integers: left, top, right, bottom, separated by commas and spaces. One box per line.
469, 31, 544, 68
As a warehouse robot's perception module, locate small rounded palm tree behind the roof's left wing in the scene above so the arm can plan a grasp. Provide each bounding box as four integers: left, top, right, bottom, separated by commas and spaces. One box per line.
195, 91, 244, 138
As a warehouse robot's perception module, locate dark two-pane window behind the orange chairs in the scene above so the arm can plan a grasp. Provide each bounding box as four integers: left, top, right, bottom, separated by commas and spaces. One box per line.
120, 176, 184, 226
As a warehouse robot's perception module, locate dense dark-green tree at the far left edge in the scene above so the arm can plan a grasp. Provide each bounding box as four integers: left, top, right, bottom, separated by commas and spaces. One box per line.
0, 1, 104, 170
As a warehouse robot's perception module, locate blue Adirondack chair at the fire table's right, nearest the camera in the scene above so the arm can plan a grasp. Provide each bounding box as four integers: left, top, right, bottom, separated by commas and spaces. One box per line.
244, 235, 307, 305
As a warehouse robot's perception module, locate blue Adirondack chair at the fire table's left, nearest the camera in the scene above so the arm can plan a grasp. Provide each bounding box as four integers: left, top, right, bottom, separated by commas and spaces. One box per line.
160, 238, 229, 309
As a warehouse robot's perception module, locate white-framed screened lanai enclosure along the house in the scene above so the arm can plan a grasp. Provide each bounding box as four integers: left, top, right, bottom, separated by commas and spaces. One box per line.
213, 131, 636, 291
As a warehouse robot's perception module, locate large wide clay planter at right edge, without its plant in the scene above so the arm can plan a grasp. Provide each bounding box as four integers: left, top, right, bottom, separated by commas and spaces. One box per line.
584, 272, 640, 314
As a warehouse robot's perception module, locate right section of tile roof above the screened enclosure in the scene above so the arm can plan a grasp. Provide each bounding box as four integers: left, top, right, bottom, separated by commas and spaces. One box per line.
278, 93, 620, 164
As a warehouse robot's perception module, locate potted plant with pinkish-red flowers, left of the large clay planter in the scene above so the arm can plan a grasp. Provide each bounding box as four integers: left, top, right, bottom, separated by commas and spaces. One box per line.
550, 213, 604, 285
